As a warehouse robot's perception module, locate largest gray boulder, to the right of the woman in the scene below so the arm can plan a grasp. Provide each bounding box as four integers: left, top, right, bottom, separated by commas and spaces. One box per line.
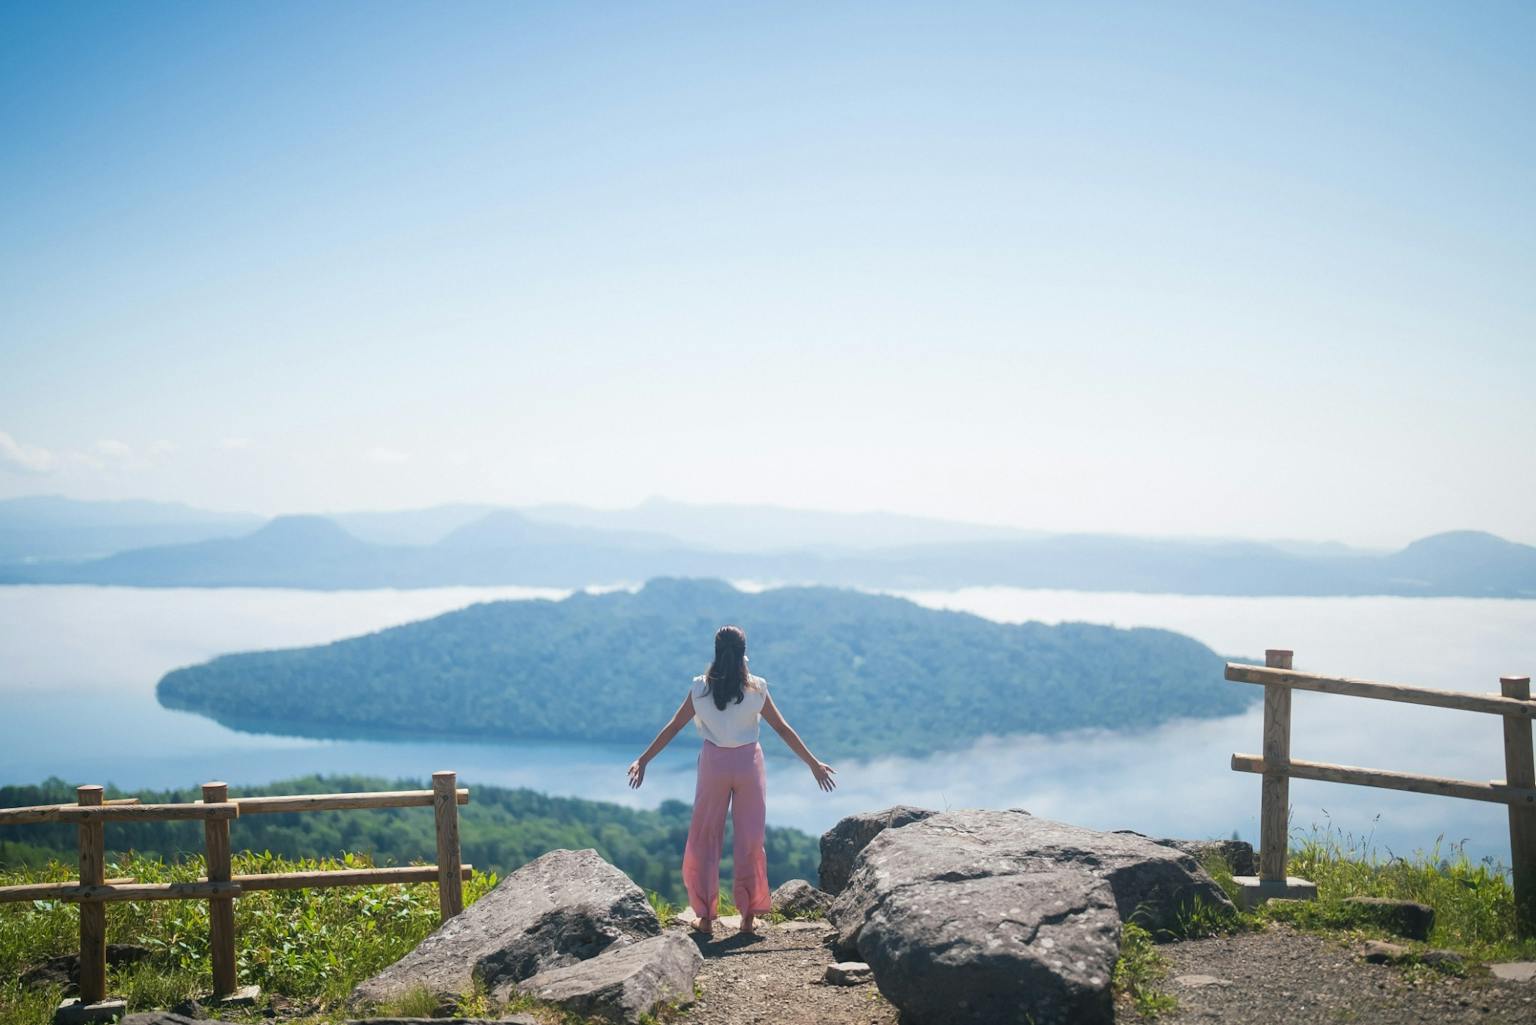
828, 811, 1230, 1025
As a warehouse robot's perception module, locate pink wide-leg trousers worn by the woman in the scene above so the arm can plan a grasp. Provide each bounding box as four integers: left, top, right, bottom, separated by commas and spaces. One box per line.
682, 741, 770, 917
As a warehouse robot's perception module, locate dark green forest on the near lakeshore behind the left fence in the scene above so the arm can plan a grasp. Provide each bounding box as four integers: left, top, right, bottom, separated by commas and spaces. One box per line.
0, 776, 820, 904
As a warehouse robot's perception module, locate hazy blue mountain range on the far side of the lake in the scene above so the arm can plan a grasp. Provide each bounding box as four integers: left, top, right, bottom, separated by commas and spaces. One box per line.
0, 503, 1536, 598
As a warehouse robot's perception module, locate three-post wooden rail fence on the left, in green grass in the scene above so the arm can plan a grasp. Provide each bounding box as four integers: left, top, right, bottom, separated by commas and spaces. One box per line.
0, 771, 472, 1005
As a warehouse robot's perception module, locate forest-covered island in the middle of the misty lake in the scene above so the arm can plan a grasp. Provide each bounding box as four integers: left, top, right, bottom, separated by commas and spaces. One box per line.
158, 579, 1256, 758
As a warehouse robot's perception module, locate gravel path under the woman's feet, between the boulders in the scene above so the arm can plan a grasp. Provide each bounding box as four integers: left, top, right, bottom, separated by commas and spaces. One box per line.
680, 922, 897, 1025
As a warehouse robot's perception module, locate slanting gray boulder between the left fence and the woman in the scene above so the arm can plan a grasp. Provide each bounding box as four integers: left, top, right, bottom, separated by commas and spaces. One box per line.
352, 850, 662, 1003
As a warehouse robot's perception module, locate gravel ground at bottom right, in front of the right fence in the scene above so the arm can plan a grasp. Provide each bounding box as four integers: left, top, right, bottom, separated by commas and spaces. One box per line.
1117, 925, 1536, 1025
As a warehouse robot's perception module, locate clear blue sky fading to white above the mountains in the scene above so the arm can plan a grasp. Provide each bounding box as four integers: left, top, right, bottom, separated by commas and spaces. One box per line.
0, 3, 1536, 544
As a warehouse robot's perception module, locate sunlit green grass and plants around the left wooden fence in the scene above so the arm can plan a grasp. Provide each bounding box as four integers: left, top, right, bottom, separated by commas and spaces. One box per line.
0, 853, 496, 1025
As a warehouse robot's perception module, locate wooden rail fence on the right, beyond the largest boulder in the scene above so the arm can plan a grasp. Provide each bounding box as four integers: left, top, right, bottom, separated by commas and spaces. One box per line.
1226, 649, 1536, 937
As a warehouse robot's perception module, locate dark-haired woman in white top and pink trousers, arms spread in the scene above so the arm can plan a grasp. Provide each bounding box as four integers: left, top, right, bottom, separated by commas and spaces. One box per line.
630, 627, 837, 936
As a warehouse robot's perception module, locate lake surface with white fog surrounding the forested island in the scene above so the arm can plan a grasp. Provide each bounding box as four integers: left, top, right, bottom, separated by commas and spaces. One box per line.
0, 587, 1536, 861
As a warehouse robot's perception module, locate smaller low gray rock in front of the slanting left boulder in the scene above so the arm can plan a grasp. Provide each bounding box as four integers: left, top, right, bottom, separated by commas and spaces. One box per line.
509, 931, 703, 1025
